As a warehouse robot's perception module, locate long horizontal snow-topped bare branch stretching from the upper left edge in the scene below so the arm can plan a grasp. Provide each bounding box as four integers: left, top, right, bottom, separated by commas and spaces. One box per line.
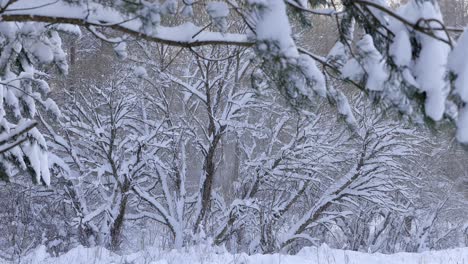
1, 0, 254, 47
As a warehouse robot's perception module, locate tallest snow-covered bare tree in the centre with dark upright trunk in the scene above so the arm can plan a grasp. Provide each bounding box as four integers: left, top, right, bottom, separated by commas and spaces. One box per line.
128, 44, 260, 247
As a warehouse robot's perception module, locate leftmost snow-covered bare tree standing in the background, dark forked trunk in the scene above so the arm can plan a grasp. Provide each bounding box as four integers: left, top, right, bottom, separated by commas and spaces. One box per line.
42, 68, 154, 249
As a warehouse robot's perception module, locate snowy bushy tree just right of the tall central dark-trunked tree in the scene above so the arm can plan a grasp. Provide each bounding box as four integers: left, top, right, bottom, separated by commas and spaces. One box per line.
215, 108, 343, 252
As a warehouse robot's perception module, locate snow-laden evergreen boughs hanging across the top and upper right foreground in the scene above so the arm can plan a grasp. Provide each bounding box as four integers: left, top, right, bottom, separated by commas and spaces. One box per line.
0, 0, 467, 146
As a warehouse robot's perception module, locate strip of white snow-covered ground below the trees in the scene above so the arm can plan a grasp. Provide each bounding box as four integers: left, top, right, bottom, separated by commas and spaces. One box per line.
5, 245, 468, 264
